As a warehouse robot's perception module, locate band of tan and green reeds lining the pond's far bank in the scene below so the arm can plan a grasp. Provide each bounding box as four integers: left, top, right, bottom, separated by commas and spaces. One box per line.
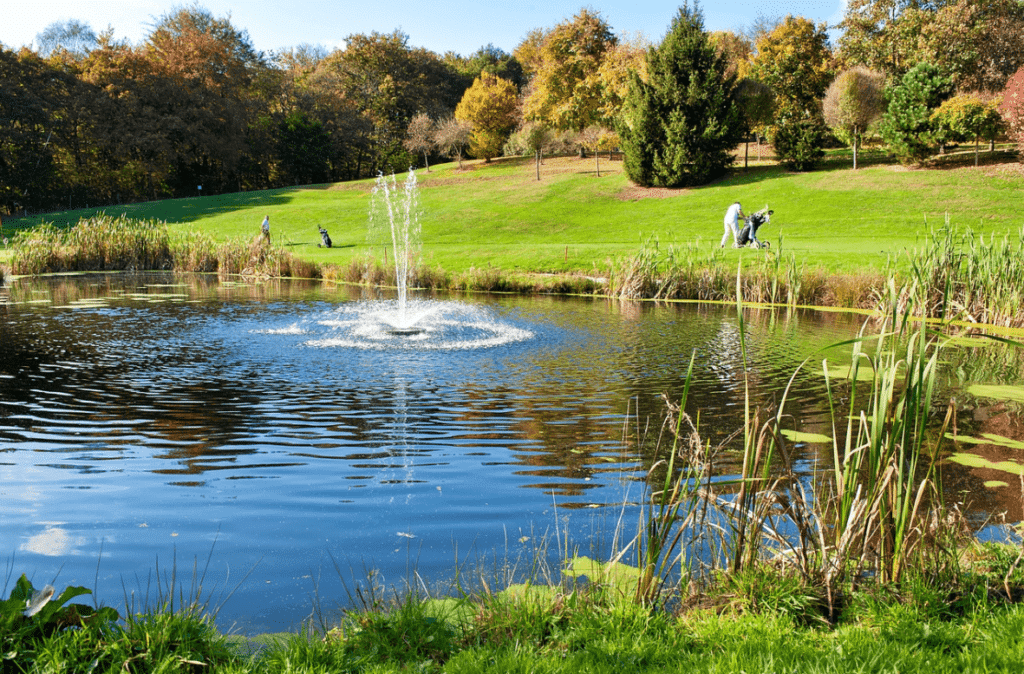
10, 209, 1024, 327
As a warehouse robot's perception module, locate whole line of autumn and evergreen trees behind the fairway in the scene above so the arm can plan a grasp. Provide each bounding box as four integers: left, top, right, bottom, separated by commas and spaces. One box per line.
0, 0, 1024, 213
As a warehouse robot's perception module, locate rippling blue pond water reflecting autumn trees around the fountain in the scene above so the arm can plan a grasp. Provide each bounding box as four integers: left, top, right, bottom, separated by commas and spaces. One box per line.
0, 275, 1024, 633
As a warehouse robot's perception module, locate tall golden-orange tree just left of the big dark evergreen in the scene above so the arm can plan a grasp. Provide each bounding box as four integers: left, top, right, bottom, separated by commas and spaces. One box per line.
523, 9, 617, 131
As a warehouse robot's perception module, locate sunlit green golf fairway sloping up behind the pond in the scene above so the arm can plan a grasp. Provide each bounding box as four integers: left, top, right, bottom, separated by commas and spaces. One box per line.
4, 153, 1024, 273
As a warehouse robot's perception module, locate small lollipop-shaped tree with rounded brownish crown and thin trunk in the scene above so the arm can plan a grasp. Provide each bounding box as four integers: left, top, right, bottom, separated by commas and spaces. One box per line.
822, 66, 885, 170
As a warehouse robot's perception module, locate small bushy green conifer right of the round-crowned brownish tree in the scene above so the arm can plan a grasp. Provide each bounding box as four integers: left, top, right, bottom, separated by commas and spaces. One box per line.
879, 64, 951, 164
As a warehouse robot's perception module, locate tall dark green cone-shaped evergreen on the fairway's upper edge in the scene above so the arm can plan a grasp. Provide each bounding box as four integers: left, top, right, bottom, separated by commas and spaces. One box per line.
618, 3, 741, 186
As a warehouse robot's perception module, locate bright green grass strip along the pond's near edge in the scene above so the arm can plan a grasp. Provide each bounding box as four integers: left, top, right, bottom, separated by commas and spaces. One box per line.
12, 557, 1024, 674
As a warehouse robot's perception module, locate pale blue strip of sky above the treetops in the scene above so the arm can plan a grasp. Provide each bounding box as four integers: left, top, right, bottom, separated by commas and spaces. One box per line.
0, 0, 844, 55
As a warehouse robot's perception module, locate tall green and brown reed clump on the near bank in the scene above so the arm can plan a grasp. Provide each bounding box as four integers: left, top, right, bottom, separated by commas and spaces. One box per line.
628, 268, 963, 619
